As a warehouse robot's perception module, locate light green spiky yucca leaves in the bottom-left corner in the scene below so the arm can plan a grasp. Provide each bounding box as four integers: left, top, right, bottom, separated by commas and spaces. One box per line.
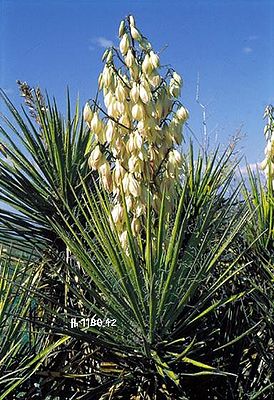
0, 247, 68, 400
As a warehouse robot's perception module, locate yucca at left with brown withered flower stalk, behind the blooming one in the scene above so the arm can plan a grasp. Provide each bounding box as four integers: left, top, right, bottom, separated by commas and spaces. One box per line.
0, 83, 100, 396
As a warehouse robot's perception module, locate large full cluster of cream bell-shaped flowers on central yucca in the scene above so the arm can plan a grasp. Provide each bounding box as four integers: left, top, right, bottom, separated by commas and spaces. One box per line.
84, 16, 188, 244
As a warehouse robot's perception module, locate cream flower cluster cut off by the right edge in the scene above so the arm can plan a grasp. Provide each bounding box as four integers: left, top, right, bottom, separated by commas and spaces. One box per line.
261, 105, 274, 189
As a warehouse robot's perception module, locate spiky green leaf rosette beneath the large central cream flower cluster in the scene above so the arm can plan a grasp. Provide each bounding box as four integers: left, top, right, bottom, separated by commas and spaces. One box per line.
24, 142, 260, 399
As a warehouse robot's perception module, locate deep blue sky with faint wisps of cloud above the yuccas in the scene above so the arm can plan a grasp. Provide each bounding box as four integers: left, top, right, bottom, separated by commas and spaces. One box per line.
0, 0, 274, 163
